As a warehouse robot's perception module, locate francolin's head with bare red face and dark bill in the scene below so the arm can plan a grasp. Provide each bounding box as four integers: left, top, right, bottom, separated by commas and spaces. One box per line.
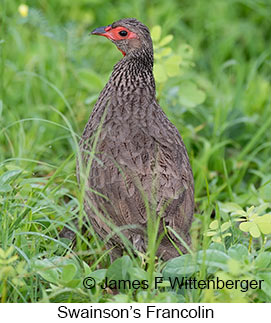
91, 18, 153, 56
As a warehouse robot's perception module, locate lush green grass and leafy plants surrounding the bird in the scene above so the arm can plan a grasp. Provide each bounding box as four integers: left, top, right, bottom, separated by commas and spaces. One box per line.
0, 0, 271, 302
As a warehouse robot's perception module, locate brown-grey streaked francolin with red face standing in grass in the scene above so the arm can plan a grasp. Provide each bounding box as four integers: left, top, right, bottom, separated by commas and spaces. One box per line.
77, 18, 194, 261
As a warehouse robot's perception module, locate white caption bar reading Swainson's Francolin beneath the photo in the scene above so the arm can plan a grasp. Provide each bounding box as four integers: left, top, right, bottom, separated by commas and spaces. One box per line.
0, 303, 271, 323
